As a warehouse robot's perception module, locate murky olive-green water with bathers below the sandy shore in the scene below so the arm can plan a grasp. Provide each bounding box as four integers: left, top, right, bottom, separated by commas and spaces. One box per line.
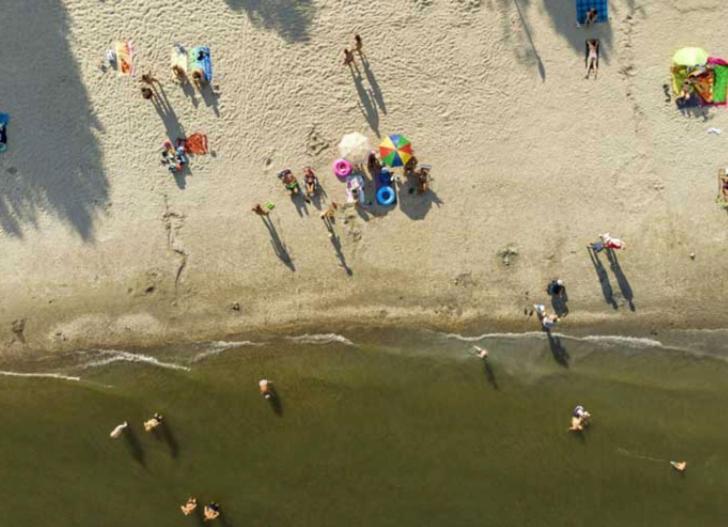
0, 330, 728, 527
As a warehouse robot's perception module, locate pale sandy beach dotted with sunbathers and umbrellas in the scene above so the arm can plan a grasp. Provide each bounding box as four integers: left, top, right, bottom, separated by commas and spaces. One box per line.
0, 0, 728, 354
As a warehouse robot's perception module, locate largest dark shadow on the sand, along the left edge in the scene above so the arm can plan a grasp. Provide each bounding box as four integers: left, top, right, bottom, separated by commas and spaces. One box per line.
0, 0, 109, 242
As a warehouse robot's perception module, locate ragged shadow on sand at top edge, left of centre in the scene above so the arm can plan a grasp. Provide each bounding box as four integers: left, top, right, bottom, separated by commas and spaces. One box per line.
220, 0, 316, 42
